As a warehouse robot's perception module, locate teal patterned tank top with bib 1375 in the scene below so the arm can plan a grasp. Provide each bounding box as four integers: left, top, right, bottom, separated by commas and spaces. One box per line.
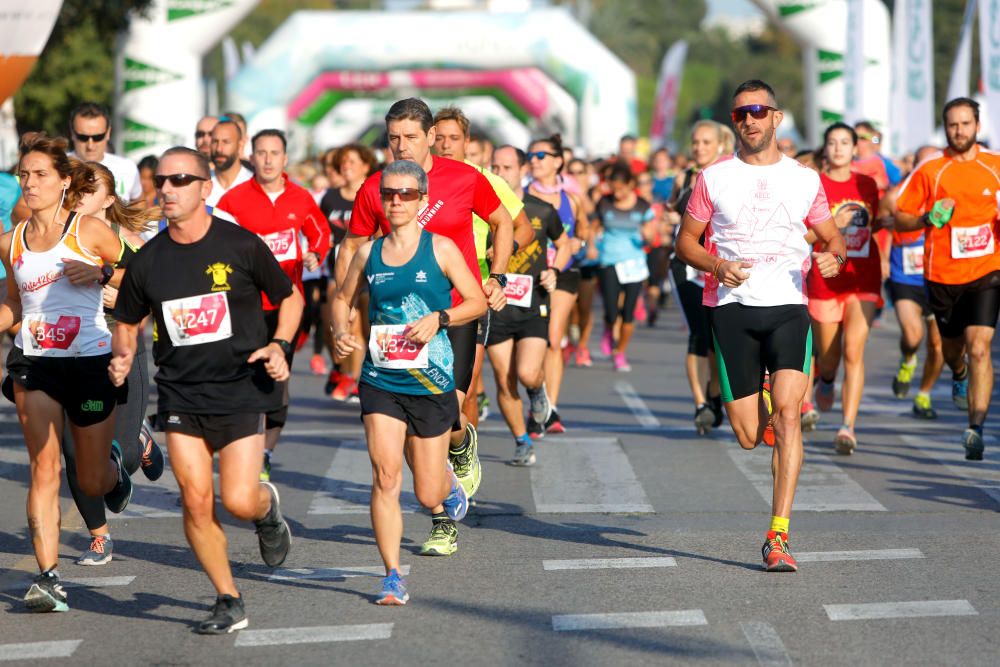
360, 231, 455, 396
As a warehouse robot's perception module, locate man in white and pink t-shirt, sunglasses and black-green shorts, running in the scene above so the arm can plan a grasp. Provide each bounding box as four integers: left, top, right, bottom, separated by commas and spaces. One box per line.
677, 79, 847, 572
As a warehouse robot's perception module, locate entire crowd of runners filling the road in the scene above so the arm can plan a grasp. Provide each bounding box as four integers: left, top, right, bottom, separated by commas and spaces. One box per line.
0, 80, 1000, 634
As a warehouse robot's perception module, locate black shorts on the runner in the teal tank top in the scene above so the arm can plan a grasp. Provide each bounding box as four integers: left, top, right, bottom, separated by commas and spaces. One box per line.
358, 380, 461, 438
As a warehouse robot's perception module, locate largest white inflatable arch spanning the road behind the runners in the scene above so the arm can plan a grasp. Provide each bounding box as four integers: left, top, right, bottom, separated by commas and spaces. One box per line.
227, 8, 637, 153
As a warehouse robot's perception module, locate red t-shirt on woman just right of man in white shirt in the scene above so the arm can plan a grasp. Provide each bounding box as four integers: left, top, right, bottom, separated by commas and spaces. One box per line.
807, 173, 882, 299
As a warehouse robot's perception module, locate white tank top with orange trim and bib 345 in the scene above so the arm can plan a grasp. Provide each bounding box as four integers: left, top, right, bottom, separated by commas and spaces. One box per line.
10, 213, 111, 357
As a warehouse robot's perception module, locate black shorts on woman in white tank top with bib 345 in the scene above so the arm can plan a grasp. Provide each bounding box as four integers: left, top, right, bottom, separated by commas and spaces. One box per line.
3, 345, 128, 426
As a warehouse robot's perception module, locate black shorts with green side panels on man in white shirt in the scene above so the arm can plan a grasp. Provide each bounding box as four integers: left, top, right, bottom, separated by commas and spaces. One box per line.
708, 303, 812, 403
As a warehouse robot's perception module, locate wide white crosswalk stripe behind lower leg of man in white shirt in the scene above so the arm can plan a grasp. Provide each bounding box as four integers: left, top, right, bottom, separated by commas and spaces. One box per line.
728, 445, 886, 512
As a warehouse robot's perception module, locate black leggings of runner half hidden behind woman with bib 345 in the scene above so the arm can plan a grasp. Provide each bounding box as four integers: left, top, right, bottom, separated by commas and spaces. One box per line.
62, 340, 149, 530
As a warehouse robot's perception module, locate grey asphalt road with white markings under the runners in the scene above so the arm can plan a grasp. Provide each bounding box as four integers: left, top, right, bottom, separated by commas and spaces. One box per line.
0, 302, 1000, 666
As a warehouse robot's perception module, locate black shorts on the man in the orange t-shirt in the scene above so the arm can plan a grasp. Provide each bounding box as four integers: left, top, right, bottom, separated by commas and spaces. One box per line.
926, 271, 1000, 338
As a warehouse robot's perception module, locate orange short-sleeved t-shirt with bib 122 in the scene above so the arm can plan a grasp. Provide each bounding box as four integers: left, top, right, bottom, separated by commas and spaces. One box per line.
896, 148, 1000, 285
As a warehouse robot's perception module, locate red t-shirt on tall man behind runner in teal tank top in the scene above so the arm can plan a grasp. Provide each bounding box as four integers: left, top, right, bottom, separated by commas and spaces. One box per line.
350, 156, 501, 302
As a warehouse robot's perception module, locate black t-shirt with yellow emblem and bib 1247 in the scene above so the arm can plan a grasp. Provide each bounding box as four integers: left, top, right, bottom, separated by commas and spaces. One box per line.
114, 217, 292, 414
